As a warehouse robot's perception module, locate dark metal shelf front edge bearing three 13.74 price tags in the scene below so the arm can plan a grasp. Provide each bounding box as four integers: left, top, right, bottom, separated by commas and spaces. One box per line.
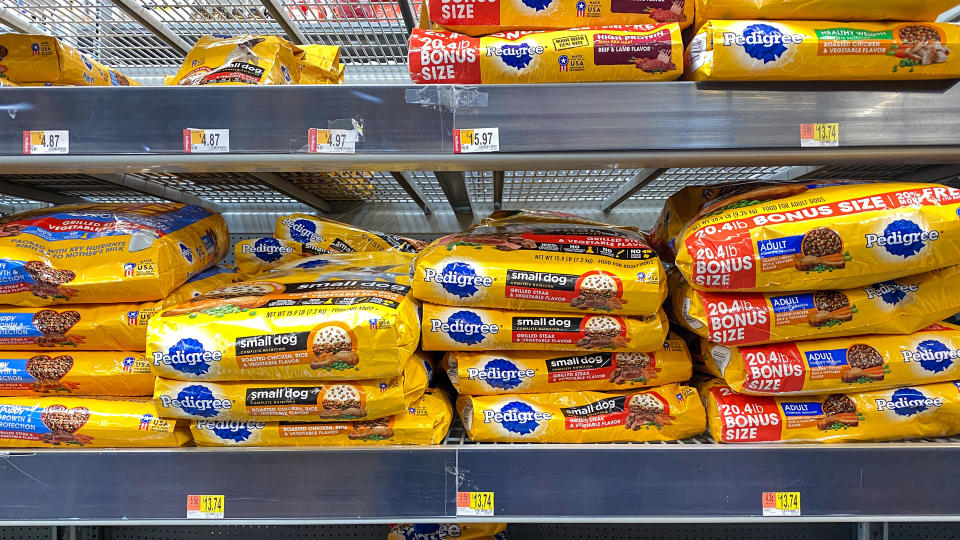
9, 440, 960, 525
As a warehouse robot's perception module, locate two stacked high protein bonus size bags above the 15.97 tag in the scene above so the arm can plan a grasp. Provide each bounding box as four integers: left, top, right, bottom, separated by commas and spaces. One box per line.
408, 0, 694, 84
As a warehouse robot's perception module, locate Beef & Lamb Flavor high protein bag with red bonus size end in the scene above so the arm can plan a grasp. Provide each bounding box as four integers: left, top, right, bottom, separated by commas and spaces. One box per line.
409, 25, 683, 84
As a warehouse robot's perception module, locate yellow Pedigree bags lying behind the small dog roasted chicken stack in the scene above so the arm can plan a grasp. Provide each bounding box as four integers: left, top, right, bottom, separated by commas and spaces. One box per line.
234, 214, 424, 277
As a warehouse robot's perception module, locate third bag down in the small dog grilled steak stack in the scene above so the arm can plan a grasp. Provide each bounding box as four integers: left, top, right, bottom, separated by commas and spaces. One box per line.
443, 335, 692, 396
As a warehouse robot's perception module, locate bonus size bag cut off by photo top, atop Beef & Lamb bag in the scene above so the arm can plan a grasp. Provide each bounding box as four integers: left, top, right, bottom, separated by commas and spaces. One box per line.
420, 0, 694, 36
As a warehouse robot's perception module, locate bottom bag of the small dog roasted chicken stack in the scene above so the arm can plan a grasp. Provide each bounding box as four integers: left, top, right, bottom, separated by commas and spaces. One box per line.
190, 390, 453, 446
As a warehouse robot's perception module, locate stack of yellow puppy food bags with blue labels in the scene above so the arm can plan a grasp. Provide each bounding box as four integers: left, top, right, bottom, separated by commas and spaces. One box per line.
0, 204, 229, 448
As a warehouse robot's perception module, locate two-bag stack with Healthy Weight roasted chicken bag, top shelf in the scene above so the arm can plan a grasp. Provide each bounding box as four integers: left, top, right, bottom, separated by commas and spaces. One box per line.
687, 0, 960, 81
